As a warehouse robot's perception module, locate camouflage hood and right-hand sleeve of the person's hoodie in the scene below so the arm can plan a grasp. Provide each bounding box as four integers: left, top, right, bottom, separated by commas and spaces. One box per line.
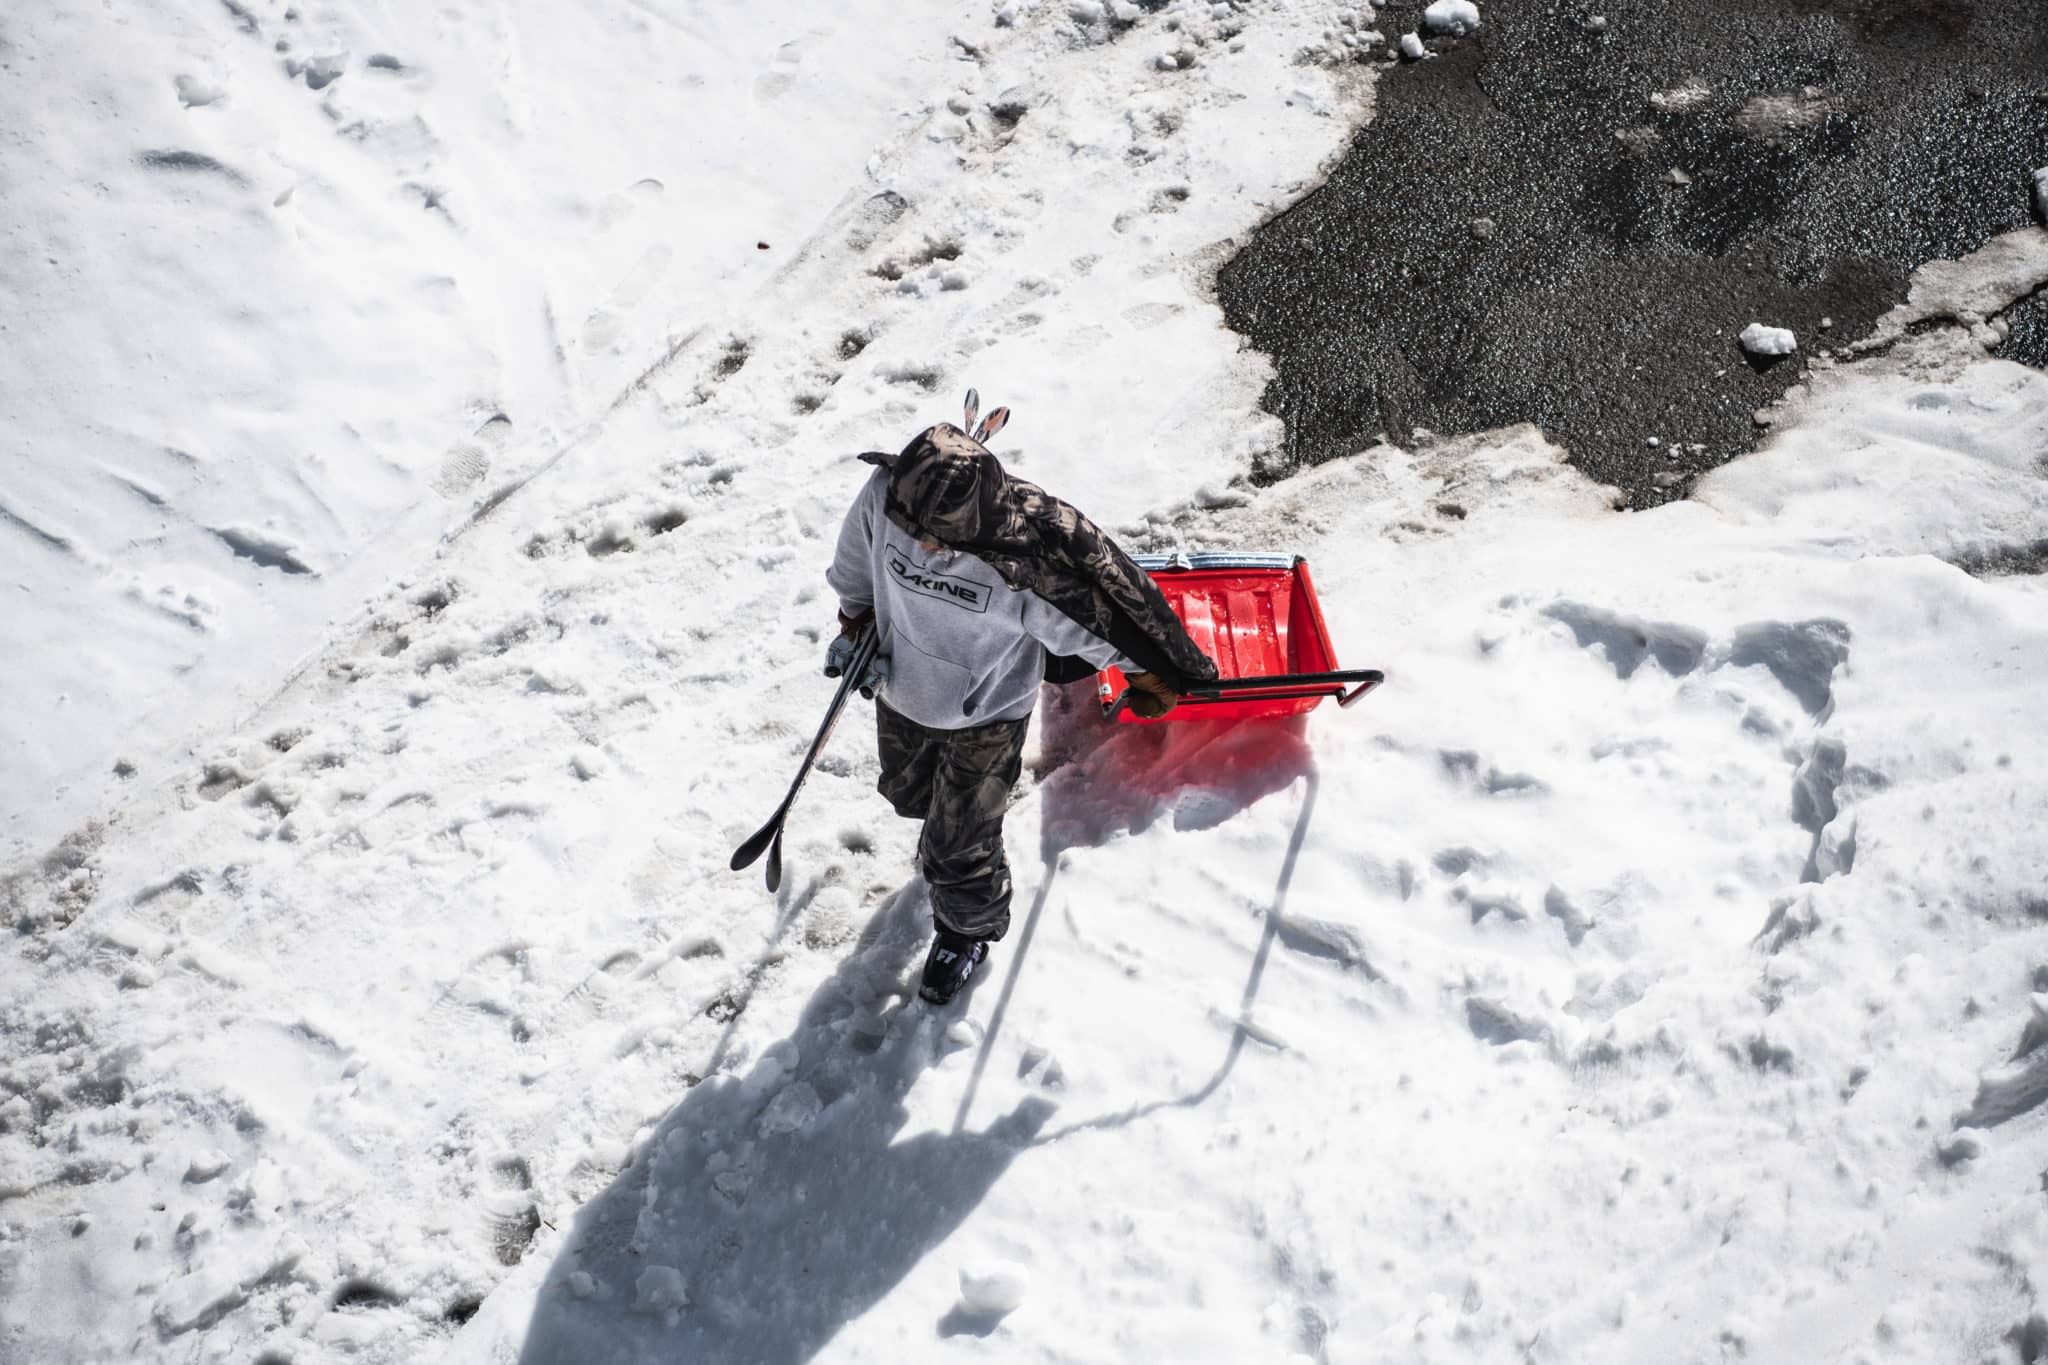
860, 422, 1217, 690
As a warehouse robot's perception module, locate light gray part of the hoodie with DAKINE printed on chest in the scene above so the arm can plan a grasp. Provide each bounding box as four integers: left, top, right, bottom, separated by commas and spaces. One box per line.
825, 469, 1137, 731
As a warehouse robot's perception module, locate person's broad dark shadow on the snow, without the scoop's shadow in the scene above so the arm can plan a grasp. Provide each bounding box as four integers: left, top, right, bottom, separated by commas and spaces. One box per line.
518, 882, 1053, 1365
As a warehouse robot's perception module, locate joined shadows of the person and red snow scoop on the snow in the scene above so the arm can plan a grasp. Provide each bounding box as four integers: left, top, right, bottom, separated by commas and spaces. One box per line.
501, 688, 1315, 1365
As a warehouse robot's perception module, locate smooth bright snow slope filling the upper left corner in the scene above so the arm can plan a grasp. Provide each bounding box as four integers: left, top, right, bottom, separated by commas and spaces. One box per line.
0, 0, 983, 855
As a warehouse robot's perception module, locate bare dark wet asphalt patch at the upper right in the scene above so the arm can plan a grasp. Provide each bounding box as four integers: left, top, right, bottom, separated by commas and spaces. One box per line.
1219, 0, 2048, 505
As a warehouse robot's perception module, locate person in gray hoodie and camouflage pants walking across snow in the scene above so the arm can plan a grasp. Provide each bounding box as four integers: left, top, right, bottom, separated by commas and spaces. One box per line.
825, 395, 1217, 1005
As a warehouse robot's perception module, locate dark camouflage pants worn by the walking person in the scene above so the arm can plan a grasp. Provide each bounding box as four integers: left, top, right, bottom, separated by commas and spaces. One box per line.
874, 702, 1030, 939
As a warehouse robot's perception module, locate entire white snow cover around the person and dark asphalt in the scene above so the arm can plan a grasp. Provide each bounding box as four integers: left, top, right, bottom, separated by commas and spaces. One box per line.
0, 0, 2048, 1365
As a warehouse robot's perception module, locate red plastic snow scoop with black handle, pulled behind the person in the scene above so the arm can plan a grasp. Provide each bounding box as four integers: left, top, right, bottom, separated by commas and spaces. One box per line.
1096, 553, 1386, 722
